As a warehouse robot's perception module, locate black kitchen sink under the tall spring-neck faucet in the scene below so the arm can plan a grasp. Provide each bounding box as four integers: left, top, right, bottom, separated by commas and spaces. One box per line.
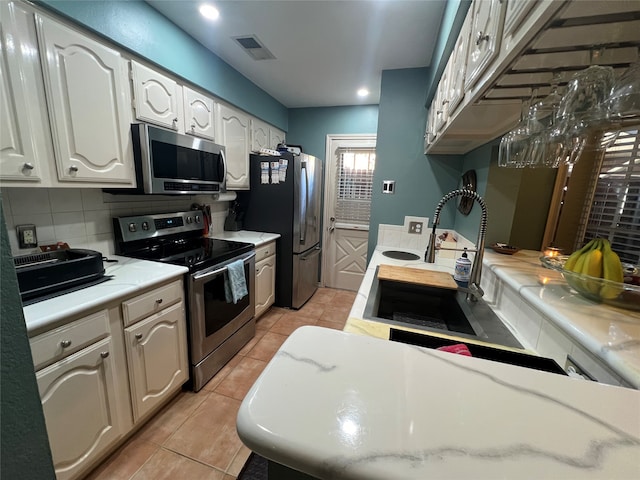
364, 266, 522, 348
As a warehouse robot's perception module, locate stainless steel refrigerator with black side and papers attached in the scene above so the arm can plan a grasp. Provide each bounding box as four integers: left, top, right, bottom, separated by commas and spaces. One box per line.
238, 153, 322, 308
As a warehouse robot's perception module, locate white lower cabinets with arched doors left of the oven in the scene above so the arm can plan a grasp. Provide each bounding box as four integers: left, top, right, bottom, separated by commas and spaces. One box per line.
29, 280, 188, 480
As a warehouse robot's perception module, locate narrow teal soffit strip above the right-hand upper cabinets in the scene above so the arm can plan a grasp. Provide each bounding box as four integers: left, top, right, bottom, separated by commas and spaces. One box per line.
425, 0, 471, 107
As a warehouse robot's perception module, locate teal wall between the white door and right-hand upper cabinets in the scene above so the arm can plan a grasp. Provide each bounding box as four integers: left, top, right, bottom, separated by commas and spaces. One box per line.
368, 68, 462, 257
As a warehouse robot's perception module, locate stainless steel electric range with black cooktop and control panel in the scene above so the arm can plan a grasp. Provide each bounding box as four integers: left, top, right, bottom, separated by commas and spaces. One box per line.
113, 210, 255, 391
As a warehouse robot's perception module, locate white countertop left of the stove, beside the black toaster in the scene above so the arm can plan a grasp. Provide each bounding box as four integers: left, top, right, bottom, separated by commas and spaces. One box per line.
23, 255, 189, 337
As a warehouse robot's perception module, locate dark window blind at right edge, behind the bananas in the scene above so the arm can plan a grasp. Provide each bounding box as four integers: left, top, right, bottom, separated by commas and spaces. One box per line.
584, 128, 640, 264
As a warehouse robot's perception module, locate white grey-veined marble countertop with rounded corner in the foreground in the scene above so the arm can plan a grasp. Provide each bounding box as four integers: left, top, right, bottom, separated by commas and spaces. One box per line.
237, 326, 640, 480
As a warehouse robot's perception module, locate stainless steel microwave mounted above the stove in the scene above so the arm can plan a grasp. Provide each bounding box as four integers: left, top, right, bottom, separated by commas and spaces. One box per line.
131, 123, 227, 195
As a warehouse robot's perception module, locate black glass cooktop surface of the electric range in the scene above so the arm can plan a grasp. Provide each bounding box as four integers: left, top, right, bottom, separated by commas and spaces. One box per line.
124, 237, 254, 269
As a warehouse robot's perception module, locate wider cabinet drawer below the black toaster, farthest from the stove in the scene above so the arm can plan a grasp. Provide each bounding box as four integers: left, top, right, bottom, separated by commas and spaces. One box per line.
30, 310, 109, 371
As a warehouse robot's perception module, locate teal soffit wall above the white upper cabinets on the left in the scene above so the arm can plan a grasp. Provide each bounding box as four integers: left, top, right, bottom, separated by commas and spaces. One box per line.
36, 0, 288, 131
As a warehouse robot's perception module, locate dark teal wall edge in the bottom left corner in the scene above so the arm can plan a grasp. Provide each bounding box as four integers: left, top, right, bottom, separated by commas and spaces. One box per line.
0, 195, 55, 480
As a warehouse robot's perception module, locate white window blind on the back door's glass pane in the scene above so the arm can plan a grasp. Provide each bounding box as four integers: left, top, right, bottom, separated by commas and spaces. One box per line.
335, 149, 376, 225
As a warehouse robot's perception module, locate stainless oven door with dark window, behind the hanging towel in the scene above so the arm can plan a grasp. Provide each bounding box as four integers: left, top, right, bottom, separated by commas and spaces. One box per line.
189, 251, 256, 365
